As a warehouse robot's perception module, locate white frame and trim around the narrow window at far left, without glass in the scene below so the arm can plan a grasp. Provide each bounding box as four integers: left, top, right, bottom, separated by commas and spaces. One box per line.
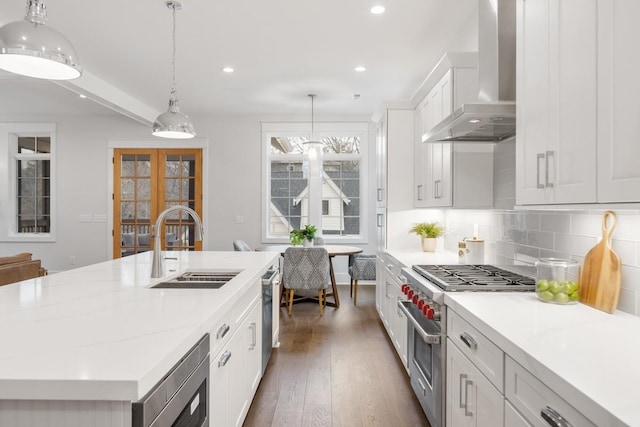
0, 123, 58, 243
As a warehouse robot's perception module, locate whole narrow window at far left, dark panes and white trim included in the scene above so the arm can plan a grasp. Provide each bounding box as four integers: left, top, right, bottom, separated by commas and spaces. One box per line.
0, 123, 56, 242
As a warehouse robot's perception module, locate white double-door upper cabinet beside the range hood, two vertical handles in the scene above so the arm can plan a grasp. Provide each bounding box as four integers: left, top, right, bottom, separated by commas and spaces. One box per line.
516, 0, 597, 205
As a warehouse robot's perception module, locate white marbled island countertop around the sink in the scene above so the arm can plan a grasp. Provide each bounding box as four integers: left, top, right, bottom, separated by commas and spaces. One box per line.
0, 252, 279, 401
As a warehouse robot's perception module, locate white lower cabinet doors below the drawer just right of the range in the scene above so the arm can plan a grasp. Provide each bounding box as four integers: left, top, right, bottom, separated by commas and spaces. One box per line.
446, 339, 504, 427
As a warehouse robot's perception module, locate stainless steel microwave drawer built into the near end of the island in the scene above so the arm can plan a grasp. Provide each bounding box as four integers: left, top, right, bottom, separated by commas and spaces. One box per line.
131, 334, 210, 427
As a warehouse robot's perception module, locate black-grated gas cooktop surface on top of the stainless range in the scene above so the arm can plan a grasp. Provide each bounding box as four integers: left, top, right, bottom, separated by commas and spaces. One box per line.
413, 264, 535, 291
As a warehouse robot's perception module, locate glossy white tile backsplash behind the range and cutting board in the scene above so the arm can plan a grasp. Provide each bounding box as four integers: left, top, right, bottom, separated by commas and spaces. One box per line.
444, 209, 640, 316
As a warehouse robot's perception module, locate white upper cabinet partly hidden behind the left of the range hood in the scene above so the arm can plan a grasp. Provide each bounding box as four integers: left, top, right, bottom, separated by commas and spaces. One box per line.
413, 52, 493, 208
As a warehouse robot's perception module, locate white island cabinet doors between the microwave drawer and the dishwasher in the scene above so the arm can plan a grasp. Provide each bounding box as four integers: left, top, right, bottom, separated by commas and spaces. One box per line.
209, 286, 262, 427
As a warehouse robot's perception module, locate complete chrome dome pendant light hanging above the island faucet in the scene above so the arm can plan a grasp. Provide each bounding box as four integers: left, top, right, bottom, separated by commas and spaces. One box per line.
153, 1, 196, 139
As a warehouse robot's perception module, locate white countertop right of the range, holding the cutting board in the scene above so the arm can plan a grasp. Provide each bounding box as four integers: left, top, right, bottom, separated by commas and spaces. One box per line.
445, 292, 640, 426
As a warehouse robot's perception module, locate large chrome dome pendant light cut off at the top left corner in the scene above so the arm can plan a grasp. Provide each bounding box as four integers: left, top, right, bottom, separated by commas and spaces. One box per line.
0, 0, 82, 80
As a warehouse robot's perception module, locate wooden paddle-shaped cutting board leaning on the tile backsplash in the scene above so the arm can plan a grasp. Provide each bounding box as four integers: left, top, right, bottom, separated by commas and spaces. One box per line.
580, 211, 620, 313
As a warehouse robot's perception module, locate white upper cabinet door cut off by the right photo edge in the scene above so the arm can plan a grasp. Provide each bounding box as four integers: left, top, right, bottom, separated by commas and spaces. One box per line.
598, 0, 640, 202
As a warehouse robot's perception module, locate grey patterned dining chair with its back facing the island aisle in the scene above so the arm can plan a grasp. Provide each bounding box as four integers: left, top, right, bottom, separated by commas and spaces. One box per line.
282, 247, 331, 316
